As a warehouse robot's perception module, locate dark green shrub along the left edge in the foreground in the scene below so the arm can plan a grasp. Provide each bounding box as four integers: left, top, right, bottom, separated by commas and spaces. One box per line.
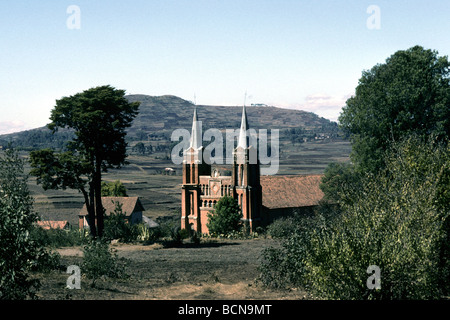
0, 149, 53, 300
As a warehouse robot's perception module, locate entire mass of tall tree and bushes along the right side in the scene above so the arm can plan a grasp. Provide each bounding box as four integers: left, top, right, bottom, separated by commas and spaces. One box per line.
260, 47, 450, 299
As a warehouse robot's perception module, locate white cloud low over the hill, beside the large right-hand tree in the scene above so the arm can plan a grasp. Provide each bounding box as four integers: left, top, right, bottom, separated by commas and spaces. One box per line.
285, 93, 352, 121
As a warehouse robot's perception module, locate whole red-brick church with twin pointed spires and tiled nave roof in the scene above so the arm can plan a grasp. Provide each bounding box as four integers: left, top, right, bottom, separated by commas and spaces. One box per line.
181, 106, 323, 234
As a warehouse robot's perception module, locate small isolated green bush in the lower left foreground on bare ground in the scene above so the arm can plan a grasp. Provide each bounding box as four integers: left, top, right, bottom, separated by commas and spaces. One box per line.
81, 239, 127, 287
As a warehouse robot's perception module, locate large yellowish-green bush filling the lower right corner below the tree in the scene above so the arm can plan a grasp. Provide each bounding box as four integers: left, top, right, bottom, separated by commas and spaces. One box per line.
261, 137, 450, 299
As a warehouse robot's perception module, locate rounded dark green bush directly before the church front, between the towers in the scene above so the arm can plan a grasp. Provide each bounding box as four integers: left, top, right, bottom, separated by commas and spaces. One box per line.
206, 196, 242, 235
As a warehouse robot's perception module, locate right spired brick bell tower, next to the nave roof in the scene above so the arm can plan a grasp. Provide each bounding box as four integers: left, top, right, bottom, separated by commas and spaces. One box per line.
232, 105, 262, 232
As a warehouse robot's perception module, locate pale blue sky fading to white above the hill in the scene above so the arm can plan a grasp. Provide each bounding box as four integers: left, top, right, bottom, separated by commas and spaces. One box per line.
0, 0, 450, 134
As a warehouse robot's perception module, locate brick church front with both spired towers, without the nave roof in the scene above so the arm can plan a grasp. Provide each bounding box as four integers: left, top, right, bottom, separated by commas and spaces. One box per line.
181, 106, 262, 233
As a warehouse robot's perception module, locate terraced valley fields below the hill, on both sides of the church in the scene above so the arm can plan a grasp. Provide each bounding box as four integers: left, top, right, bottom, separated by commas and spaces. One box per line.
14, 141, 351, 225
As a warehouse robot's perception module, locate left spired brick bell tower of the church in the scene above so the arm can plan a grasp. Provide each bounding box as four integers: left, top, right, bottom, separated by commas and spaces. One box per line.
181, 107, 211, 231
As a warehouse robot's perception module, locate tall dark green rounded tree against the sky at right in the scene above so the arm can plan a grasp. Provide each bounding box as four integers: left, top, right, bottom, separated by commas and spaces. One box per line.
339, 46, 450, 172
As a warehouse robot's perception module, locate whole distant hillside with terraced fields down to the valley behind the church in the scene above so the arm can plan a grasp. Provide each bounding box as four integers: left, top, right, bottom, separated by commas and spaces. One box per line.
0, 95, 351, 226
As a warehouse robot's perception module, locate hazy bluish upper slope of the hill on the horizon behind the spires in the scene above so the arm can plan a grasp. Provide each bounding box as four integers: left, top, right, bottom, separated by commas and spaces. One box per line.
0, 95, 337, 150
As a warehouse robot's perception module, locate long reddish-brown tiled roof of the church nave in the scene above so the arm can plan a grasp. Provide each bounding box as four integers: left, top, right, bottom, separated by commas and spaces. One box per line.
261, 174, 324, 209
